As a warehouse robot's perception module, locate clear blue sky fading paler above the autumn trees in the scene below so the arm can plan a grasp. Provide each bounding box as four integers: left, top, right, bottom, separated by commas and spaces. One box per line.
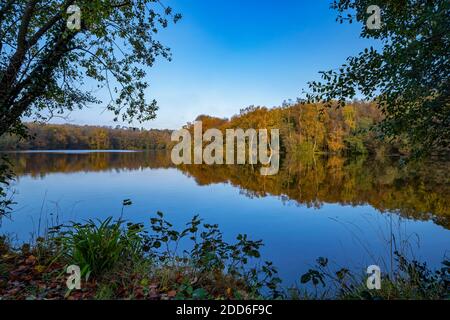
53, 0, 373, 129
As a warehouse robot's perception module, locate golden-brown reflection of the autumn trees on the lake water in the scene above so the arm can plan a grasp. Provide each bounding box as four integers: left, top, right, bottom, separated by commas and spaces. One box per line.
9, 152, 450, 229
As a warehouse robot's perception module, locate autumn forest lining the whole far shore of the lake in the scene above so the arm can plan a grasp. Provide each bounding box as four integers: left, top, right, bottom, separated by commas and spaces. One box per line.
0, 101, 409, 155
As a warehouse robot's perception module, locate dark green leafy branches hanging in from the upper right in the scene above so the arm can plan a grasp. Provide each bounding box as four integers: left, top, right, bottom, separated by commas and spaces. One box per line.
307, 0, 450, 154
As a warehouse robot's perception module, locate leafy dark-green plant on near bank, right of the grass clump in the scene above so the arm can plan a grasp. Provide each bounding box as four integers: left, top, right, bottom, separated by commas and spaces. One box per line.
148, 212, 281, 298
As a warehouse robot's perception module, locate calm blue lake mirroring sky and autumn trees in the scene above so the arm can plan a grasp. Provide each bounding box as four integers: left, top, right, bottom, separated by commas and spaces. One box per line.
0, 151, 450, 285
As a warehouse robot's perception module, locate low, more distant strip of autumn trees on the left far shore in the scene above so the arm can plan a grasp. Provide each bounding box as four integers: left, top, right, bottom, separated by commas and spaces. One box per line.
0, 123, 172, 150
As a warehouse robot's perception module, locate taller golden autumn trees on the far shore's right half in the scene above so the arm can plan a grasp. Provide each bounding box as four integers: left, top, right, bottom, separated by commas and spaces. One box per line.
186, 101, 408, 155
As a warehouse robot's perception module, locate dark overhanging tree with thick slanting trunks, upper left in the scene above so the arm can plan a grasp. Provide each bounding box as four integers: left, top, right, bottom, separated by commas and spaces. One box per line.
0, 0, 180, 135
